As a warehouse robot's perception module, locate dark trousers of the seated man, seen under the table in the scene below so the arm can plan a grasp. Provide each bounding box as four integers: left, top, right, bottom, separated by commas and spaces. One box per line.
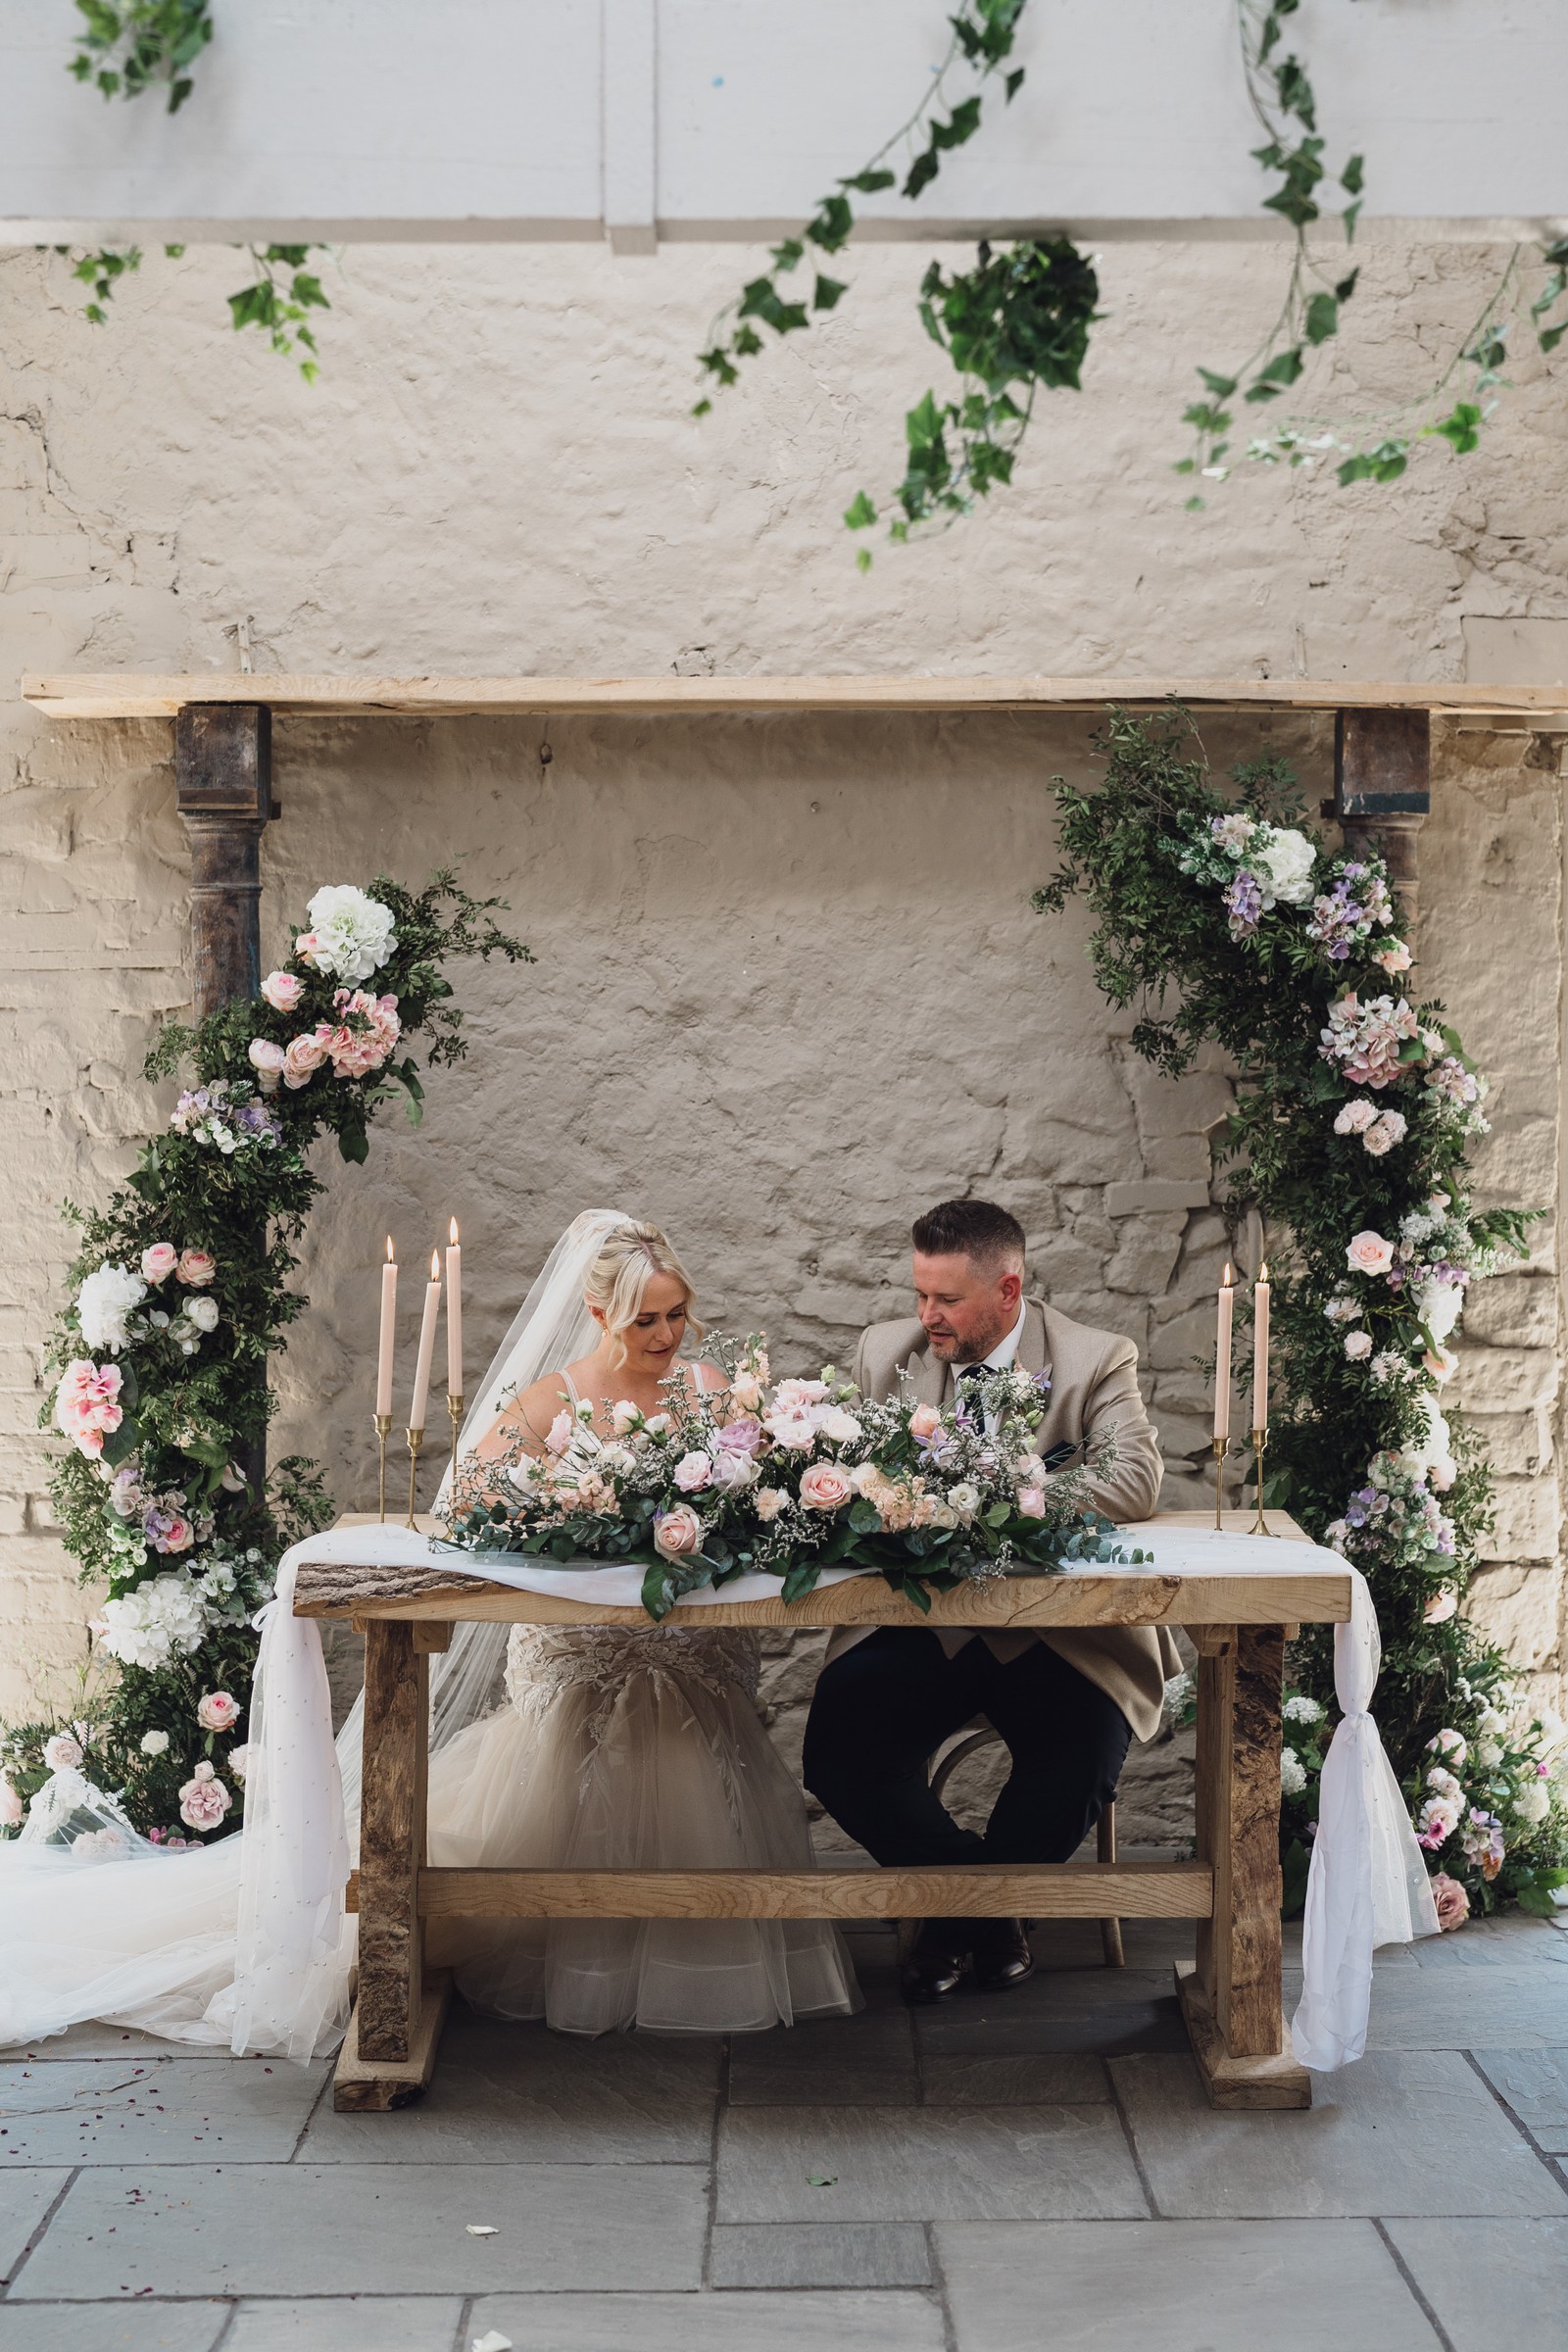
804, 1628, 1133, 1919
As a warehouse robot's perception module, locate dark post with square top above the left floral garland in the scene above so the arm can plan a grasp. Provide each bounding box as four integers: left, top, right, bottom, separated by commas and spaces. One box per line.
174, 704, 272, 1021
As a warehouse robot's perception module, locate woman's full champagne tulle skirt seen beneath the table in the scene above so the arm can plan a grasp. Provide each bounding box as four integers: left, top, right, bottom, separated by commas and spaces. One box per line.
428, 1625, 860, 2034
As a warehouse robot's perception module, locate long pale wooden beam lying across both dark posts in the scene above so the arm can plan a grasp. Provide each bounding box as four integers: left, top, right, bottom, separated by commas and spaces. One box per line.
22, 670, 1568, 719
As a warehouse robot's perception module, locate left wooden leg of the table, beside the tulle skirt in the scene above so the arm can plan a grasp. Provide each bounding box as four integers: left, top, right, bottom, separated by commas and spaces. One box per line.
334, 1618, 452, 2112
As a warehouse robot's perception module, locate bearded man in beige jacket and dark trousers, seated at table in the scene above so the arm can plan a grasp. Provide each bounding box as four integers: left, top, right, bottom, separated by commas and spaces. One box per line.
804, 1200, 1180, 2001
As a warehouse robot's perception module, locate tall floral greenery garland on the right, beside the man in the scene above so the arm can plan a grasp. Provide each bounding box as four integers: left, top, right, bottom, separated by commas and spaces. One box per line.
1034, 708, 1568, 1912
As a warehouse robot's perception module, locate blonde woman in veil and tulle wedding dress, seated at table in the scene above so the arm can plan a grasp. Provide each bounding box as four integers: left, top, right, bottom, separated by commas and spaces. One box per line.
428, 1211, 860, 2034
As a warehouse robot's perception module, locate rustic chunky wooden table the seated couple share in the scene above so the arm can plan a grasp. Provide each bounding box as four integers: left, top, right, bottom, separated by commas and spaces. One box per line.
294, 1512, 1349, 2110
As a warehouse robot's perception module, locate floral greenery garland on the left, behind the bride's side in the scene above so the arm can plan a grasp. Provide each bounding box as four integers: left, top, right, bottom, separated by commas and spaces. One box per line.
0, 872, 529, 1839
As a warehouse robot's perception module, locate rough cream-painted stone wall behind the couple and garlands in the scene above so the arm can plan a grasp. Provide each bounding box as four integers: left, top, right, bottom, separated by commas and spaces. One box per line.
0, 233, 1568, 1833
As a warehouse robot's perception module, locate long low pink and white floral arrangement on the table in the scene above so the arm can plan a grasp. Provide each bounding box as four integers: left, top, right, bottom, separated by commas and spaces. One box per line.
447, 1339, 1148, 1618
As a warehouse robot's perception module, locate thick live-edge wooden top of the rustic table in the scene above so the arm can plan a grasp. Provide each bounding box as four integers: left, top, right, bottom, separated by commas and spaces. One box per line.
294, 1510, 1349, 1628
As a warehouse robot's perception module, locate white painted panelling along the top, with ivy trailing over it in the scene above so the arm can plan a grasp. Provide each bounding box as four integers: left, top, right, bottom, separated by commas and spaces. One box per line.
0, 0, 1568, 249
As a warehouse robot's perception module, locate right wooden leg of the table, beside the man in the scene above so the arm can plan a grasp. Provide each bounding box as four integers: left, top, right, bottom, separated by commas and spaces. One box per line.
1175, 1625, 1312, 2107
